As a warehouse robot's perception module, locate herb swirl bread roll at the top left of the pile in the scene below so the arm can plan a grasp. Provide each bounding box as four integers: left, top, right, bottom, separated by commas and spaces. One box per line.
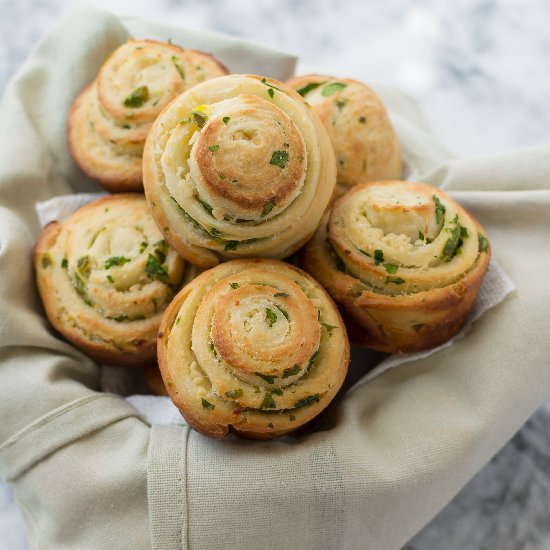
68, 40, 227, 192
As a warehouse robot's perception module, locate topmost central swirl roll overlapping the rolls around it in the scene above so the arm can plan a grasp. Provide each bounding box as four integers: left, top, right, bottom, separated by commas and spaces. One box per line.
143, 75, 336, 268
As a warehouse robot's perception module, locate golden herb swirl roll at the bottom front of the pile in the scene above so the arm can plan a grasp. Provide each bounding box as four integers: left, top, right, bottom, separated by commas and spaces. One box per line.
158, 259, 349, 439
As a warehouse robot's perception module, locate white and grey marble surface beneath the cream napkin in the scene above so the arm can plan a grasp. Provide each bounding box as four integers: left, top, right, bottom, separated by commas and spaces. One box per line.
0, 0, 550, 550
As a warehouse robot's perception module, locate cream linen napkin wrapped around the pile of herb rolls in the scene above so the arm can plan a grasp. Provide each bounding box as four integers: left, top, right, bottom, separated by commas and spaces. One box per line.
0, 4, 550, 550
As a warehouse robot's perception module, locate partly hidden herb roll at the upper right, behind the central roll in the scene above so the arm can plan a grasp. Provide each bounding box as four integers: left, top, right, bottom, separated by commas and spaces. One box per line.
287, 75, 402, 197
